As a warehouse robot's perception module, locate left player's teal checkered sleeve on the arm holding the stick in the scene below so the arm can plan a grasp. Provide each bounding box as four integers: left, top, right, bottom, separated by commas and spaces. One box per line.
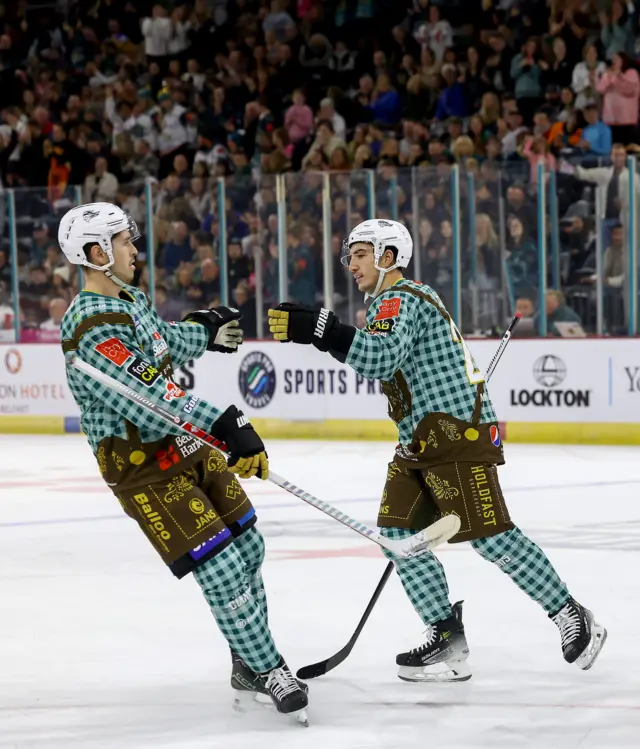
72, 324, 221, 433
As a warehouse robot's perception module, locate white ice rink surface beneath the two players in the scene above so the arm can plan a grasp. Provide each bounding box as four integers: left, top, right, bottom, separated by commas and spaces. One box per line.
0, 435, 640, 749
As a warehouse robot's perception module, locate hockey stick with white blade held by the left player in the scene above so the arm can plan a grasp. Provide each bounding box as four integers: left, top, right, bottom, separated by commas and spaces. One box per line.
67, 355, 460, 558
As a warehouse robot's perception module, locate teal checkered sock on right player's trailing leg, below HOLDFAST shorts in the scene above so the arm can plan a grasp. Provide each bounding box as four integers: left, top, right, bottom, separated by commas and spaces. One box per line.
471, 528, 571, 614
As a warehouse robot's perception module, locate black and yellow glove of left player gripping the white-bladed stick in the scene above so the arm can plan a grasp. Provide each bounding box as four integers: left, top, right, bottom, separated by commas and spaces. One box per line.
211, 406, 269, 481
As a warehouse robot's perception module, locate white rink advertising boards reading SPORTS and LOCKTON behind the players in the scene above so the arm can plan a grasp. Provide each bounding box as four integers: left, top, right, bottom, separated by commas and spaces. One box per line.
0, 339, 640, 424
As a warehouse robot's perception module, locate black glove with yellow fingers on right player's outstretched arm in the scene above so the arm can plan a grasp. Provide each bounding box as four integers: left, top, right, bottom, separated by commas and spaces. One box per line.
268, 302, 356, 361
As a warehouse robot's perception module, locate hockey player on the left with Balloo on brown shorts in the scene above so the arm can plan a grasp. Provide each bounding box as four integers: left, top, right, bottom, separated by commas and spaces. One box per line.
58, 203, 307, 723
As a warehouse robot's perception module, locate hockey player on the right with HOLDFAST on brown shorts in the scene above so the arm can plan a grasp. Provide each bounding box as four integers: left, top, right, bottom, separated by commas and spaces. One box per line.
269, 219, 607, 681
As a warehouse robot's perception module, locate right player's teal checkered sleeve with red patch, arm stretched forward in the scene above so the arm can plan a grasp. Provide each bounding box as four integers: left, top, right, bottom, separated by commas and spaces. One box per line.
346, 292, 428, 380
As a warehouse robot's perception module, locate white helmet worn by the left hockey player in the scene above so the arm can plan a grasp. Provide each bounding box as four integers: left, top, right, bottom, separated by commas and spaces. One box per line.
58, 203, 140, 271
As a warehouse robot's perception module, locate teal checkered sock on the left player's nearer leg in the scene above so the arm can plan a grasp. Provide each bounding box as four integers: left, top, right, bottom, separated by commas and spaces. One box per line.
193, 541, 280, 673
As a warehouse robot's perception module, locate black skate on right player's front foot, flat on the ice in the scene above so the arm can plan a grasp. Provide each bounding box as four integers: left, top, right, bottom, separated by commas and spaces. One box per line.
396, 601, 471, 681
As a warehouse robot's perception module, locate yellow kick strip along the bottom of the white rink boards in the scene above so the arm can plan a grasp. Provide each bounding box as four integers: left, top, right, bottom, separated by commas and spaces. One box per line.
0, 415, 640, 445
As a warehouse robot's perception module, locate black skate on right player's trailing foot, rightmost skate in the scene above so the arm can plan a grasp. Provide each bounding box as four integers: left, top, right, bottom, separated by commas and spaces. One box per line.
549, 598, 607, 671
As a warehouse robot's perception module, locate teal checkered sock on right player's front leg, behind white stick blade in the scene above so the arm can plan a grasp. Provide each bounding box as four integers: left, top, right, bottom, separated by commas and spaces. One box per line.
379, 528, 452, 624
